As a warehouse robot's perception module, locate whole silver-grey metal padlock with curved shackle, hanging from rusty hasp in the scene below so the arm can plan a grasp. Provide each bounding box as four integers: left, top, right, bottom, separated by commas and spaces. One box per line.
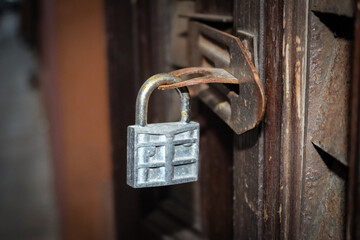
127, 74, 200, 188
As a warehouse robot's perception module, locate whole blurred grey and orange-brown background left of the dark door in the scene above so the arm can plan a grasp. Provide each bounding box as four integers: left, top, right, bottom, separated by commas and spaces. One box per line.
0, 0, 113, 240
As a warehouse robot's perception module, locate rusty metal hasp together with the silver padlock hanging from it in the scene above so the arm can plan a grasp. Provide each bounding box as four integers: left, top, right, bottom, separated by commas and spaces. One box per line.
127, 22, 265, 188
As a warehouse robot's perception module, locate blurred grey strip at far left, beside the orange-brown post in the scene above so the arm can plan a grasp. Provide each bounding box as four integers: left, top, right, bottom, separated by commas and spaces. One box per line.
0, 0, 59, 239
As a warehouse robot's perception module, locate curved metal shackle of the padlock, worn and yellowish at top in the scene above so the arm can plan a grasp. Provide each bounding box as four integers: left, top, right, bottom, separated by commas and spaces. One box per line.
135, 73, 190, 126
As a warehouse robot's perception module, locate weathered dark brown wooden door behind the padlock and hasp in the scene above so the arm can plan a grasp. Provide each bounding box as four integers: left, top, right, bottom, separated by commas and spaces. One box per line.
105, 0, 353, 239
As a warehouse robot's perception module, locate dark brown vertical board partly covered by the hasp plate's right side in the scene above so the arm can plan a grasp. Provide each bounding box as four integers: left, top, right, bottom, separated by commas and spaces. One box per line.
233, 0, 266, 239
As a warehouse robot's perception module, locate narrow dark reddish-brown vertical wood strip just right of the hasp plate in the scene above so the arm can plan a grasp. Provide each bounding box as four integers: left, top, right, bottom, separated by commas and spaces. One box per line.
263, 0, 283, 239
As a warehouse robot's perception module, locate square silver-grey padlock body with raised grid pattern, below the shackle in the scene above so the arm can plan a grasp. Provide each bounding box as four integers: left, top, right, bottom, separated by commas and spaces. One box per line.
127, 122, 200, 188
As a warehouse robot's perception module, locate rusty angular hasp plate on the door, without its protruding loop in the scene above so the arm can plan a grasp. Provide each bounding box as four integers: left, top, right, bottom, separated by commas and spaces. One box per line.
189, 21, 265, 134
